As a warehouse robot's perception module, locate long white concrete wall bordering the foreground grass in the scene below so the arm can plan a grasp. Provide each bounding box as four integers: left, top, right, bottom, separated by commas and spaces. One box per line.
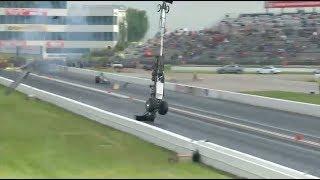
0, 77, 318, 179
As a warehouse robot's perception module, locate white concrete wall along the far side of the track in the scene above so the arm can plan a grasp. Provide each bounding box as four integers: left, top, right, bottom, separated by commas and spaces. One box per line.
60, 66, 320, 117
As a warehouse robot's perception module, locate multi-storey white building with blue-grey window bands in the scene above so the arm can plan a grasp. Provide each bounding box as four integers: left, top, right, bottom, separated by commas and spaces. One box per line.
0, 1, 126, 57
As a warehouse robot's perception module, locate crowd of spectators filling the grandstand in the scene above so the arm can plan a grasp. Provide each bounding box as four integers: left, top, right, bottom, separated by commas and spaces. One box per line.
119, 11, 320, 65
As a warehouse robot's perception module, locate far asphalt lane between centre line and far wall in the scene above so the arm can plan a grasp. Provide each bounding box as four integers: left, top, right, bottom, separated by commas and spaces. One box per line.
41, 69, 320, 140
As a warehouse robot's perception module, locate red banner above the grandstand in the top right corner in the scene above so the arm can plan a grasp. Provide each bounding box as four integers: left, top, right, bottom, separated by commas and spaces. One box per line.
265, 1, 320, 8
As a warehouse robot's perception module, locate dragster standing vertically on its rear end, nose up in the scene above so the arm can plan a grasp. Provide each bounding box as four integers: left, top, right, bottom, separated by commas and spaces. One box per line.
135, 1, 173, 122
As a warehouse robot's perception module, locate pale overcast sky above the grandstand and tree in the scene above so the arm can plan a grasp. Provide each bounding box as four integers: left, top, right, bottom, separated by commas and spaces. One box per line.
71, 1, 272, 38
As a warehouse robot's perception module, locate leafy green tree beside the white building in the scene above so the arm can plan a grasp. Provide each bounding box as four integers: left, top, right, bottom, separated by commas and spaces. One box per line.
126, 8, 149, 42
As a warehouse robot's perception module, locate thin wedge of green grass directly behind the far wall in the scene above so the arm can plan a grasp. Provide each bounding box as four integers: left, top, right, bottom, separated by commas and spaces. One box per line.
242, 91, 320, 105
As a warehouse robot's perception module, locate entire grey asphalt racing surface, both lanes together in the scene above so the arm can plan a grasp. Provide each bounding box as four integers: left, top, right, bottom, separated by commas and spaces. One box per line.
0, 71, 320, 177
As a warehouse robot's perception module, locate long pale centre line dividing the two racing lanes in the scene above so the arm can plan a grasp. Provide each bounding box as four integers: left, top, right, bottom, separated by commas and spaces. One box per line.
31, 73, 320, 147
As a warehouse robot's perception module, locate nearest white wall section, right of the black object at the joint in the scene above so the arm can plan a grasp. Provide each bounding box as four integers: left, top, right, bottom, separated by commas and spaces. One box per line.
195, 141, 316, 179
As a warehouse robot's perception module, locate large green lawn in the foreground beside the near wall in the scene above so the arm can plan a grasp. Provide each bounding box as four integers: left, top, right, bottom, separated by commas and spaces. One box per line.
0, 86, 234, 178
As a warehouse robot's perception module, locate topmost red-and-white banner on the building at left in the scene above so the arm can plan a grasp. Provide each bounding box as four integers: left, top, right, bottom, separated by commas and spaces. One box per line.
5, 8, 47, 16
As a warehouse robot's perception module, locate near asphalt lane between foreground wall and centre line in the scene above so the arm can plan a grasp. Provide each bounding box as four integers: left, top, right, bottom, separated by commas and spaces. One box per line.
0, 69, 320, 176
